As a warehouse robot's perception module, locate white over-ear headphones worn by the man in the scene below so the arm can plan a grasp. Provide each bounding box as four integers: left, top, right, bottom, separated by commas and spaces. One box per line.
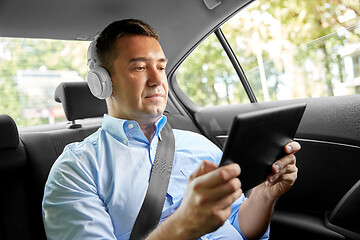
86, 40, 113, 99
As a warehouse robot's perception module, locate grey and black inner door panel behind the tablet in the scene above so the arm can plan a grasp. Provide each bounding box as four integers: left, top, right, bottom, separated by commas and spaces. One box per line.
190, 95, 360, 239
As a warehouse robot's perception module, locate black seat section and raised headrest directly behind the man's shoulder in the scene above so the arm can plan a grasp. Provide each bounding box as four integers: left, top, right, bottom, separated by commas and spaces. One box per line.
20, 82, 107, 239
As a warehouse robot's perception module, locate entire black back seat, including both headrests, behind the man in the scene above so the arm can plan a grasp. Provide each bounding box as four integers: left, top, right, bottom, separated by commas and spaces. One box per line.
0, 82, 199, 240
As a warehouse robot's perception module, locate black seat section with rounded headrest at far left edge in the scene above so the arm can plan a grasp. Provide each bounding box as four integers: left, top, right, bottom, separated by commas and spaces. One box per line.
0, 114, 32, 239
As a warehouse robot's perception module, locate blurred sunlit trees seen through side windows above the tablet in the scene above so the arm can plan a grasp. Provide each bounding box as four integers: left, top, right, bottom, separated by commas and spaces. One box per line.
177, 0, 360, 106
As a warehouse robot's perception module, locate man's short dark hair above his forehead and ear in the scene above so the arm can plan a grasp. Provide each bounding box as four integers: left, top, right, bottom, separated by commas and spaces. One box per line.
96, 19, 159, 74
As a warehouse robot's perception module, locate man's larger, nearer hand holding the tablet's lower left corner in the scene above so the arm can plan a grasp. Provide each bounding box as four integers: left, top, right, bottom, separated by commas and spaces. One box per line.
174, 160, 242, 239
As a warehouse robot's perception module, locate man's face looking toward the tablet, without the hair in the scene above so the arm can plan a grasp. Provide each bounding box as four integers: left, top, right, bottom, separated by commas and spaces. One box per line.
109, 35, 168, 121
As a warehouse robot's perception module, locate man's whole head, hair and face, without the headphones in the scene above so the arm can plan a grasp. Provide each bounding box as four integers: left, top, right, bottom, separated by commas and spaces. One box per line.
96, 19, 168, 125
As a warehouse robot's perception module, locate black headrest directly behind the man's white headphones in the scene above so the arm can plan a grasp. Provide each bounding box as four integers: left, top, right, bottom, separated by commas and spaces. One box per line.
55, 82, 107, 121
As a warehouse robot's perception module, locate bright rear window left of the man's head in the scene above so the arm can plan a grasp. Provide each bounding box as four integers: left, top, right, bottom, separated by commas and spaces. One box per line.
0, 38, 89, 127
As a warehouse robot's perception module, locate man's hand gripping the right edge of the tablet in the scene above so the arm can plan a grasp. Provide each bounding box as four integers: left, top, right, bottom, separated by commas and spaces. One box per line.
257, 142, 301, 200
